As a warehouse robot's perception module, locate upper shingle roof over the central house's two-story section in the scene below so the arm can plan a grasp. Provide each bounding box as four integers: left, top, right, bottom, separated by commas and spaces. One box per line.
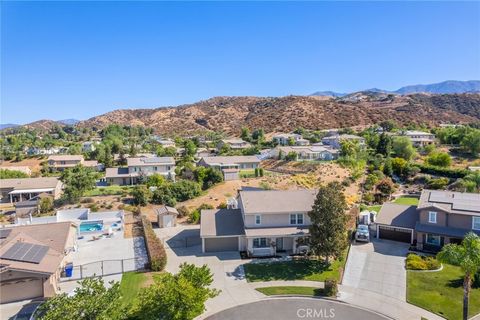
239, 190, 317, 214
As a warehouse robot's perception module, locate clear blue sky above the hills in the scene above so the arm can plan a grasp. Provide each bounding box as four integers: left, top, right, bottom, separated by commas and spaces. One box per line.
0, 1, 480, 123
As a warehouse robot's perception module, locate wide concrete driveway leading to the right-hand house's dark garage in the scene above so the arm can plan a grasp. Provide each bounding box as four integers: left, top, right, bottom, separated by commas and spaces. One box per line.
342, 239, 409, 301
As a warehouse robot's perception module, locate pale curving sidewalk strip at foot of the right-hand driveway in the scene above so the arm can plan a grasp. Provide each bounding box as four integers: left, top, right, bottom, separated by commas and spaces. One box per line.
338, 285, 444, 320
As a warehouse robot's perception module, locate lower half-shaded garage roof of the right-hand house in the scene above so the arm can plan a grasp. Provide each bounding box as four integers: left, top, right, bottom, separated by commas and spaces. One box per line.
375, 203, 418, 229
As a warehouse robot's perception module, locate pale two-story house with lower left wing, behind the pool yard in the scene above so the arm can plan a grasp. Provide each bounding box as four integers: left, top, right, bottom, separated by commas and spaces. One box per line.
105, 157, 175, 185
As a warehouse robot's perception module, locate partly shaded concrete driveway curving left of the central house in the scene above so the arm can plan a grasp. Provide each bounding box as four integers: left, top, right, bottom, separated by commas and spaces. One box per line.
155, 225, 263, 318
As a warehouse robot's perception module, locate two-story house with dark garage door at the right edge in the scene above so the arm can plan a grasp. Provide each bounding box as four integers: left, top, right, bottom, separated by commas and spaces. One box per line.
376, 190, 480, 251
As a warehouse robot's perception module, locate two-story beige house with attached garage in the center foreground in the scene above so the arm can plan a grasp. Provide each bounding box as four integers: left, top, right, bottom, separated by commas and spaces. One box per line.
200, 190, 317, 256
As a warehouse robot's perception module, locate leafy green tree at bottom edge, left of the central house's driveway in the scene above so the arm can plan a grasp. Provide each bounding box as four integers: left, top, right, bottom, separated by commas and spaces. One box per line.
129, 263, 219, 320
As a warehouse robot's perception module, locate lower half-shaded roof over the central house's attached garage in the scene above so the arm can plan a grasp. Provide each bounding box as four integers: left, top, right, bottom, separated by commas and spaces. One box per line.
200, 209, 245, 237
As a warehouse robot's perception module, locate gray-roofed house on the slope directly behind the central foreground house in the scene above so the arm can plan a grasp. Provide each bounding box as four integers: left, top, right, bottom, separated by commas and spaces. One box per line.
197, 156, 260, 181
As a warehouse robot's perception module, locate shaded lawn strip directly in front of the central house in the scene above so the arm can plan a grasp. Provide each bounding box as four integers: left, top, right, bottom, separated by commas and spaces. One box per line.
243, 259, 345, 282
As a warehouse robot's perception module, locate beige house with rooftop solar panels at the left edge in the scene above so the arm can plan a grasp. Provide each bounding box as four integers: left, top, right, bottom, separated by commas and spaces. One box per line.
0, 222, 77, 303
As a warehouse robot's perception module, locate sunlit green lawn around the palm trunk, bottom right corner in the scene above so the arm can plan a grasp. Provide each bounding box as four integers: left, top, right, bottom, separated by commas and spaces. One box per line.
407, 264, 480, 320
